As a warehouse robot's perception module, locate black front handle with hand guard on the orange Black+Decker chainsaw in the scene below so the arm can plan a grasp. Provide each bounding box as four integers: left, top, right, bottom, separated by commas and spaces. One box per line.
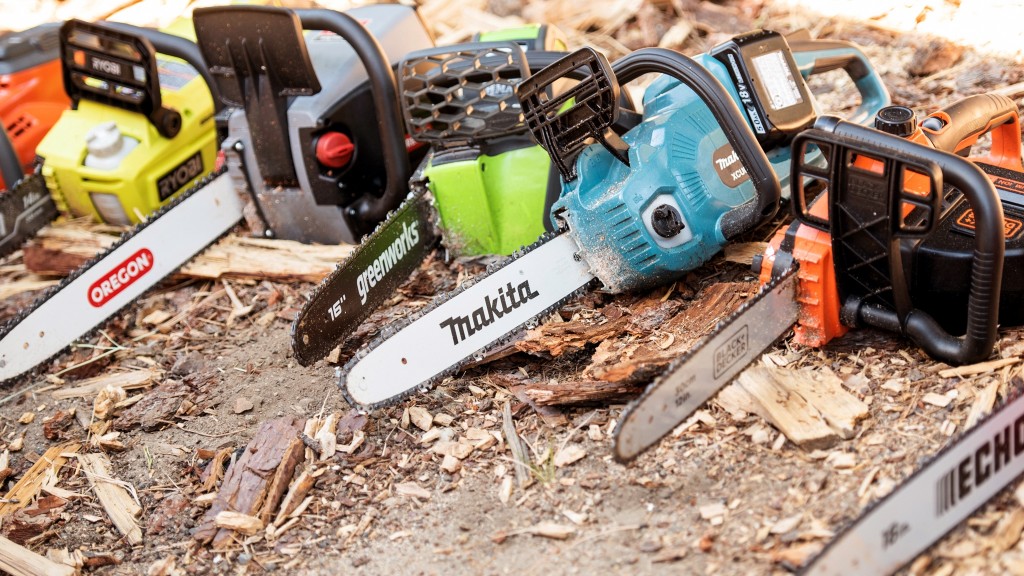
793, 116, 1006, 364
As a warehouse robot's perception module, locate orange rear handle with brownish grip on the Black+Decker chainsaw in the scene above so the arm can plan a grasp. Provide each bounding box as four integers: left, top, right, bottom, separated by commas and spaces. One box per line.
921, 93, 1024, 171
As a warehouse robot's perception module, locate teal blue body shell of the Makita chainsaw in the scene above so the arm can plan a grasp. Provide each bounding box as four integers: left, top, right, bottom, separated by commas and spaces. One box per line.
552, 54, 806, 292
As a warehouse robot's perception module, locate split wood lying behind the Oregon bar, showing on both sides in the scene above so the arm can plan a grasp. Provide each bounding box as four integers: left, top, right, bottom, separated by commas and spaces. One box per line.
25, 224, 354, 282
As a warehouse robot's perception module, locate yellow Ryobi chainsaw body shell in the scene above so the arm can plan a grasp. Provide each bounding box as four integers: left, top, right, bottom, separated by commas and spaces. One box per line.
37, 19, 217, 225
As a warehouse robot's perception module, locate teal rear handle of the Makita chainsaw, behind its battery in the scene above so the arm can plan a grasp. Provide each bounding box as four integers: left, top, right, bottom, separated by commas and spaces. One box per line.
787, 39, 892, 124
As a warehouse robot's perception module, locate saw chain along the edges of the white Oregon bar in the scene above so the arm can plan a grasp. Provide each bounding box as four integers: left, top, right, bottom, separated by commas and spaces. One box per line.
0, 168, 227, 387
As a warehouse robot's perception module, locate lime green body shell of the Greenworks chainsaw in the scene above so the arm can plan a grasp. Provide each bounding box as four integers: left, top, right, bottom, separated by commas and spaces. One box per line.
423, 134, 560, 255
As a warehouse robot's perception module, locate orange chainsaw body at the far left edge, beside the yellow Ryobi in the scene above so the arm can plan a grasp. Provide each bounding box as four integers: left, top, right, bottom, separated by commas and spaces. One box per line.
0, 24, 70, 189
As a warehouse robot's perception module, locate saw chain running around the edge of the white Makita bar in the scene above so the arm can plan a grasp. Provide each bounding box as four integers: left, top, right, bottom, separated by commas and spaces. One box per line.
337, 232, 599, 412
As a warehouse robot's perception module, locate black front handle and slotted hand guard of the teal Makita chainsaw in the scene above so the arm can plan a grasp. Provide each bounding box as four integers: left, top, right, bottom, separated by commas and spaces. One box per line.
516, 48, 781, 239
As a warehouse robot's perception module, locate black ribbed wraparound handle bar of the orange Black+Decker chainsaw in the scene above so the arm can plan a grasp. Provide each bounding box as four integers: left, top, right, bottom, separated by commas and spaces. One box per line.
815, 117, 999, 364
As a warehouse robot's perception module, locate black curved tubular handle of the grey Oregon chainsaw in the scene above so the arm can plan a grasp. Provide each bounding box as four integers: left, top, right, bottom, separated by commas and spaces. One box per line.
295, 8, 412, 221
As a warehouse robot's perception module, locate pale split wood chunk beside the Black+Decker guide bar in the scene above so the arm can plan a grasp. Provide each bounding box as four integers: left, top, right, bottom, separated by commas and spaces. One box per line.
736, 366, 839, 448
